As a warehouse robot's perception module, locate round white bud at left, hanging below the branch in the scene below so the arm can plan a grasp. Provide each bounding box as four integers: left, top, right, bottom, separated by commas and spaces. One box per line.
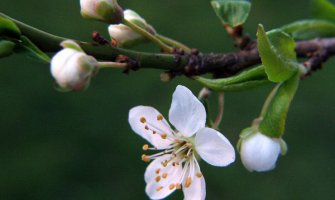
51, 41, 98, 91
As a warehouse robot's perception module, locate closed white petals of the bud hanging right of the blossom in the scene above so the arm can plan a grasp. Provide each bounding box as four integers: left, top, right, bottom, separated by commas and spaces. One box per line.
240, 133, 280, 172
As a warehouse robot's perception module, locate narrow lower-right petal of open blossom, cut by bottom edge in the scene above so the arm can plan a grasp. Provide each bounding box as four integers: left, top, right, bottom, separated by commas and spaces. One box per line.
183, 161, 206, 200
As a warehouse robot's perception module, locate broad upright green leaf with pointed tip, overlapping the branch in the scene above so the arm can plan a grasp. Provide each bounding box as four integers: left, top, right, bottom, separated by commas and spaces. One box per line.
257, 25, 298, 82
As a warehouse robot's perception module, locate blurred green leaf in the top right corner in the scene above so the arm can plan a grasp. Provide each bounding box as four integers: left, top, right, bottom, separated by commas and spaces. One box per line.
311, 0, 335, 22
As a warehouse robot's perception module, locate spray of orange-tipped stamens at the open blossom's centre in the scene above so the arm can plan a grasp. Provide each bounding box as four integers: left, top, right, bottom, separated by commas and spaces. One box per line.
140, 115, 202, 192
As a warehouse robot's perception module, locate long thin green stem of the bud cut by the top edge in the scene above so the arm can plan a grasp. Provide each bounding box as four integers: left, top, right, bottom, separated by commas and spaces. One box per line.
122, 19, 173, 53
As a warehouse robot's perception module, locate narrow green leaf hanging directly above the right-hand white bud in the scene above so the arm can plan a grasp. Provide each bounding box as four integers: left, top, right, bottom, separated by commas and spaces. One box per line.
259, 71, 300, 138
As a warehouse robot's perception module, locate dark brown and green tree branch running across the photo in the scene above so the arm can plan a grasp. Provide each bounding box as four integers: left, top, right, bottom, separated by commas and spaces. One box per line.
0, 13, 335, 77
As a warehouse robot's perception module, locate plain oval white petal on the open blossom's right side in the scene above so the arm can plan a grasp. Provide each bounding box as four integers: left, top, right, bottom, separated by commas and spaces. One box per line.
195, 128, 235, 167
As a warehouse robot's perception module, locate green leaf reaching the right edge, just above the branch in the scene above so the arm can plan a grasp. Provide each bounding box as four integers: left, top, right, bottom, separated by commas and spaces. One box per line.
280, 19, 335, 40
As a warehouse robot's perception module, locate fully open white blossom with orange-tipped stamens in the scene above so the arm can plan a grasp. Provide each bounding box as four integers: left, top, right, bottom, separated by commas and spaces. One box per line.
129, 86, 235, 200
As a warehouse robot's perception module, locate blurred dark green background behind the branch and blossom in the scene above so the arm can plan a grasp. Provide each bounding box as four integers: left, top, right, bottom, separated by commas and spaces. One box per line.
0, 0, 335, 200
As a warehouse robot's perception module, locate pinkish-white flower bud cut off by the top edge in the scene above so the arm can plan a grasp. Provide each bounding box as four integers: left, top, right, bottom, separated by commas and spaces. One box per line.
80, 0, 123, 24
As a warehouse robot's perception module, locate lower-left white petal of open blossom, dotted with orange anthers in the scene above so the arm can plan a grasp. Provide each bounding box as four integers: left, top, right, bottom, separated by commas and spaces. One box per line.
144, 154, 182, 199
